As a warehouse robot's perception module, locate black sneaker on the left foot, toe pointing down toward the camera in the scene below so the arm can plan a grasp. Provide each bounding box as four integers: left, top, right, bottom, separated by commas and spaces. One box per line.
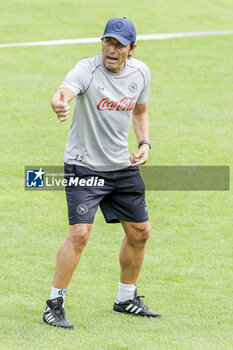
42, 297, 74, 329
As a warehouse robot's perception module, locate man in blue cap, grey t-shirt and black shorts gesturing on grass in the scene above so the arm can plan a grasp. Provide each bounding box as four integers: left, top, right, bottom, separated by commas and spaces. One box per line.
43, 17, 161, 329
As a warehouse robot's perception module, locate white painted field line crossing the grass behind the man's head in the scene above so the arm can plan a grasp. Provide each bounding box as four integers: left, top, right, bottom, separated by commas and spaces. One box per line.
0, 30, 233, 48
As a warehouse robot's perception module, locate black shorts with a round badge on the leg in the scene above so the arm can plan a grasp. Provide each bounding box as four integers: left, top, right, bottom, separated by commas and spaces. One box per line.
65, 163, 148, 225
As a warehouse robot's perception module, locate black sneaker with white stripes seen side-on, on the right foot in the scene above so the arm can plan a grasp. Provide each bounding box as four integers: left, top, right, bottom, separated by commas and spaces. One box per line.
113, 289, 162, 317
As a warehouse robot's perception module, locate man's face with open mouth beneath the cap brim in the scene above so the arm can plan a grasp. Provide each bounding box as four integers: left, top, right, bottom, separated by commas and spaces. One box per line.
102, 38, 136, 73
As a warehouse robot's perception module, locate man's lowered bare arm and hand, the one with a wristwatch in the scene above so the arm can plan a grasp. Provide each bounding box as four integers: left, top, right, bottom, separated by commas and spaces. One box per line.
130, 103, 150, 166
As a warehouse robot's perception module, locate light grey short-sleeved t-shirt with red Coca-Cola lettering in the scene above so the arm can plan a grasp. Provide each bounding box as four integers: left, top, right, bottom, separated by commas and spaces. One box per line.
60, 54, 150, 171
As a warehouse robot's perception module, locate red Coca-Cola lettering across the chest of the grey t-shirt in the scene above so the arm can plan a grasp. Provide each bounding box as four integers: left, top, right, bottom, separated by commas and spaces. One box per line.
97, 96, 136, 111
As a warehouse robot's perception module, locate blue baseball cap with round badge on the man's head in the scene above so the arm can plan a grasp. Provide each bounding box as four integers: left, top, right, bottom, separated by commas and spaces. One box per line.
101, 17, 136, 46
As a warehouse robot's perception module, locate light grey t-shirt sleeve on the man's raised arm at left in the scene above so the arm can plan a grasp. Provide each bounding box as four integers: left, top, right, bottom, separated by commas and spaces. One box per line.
60, 59, 91, 95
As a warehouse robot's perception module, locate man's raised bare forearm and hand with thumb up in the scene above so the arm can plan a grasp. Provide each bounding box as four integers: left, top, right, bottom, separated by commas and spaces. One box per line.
51, 88, 75, 122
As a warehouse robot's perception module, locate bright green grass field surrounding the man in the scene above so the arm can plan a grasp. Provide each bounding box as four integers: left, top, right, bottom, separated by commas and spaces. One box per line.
0, 0, 233, 350
